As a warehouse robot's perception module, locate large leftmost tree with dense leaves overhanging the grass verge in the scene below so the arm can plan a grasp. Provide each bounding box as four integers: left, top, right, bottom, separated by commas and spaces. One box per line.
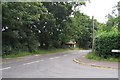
2, 2, 47, 53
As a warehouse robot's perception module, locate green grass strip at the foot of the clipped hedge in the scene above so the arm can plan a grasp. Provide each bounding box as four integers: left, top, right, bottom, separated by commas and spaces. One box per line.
85, 52, 120, 62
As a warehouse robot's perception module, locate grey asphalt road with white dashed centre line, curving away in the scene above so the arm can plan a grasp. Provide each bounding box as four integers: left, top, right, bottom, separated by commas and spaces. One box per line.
0, 50, 118, 78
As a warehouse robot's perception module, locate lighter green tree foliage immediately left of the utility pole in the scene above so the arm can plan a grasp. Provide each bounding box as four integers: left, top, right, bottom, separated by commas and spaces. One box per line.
72, 11, 98, 48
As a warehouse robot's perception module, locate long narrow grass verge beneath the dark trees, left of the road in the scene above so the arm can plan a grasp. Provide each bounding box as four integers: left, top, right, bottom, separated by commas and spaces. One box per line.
2, 49, 70, 58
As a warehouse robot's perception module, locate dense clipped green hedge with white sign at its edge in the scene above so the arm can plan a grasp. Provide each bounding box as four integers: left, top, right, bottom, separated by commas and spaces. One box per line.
94, 31, 120, 58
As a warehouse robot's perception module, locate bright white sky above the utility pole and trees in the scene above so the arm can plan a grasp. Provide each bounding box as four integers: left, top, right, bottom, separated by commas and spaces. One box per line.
80, 0, 120, 23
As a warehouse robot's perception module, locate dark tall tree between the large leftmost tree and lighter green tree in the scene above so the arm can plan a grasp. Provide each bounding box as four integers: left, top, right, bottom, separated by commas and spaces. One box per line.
43, 2, 72, 48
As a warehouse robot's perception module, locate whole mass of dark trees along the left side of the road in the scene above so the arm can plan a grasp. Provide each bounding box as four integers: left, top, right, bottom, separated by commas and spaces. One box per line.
2, 2, 91, 55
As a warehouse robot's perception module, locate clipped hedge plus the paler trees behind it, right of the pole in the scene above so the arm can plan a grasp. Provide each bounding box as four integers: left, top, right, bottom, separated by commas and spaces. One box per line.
94, 1, 120, 58
